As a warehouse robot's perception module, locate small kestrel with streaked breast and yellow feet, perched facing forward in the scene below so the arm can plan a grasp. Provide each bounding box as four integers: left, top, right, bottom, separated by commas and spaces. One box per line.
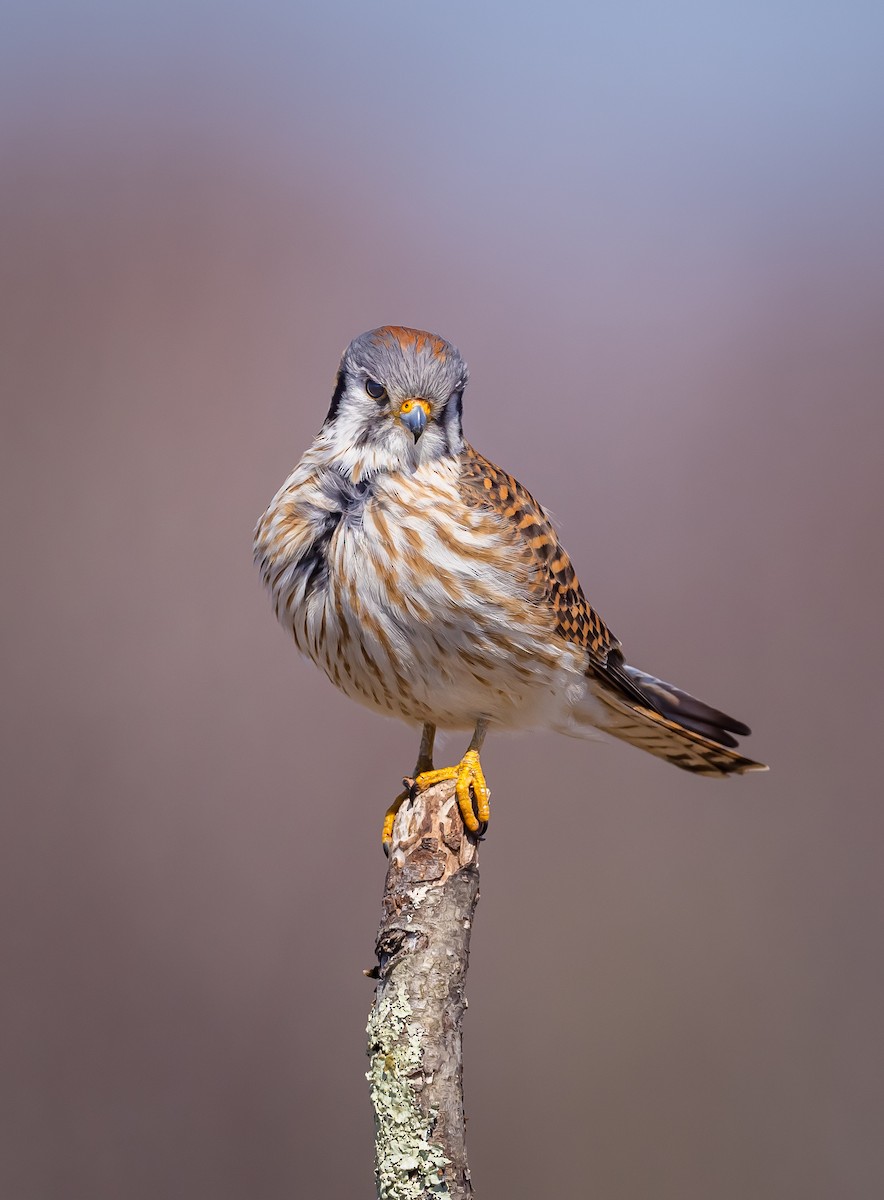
254, 325, 768, 847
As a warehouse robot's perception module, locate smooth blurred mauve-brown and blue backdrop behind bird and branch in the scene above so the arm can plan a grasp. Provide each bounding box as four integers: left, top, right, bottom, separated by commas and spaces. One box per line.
0, 0, 884, 1200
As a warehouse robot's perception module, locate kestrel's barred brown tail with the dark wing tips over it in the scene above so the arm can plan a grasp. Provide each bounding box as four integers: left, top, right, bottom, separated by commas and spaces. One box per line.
594, 664, 768, 775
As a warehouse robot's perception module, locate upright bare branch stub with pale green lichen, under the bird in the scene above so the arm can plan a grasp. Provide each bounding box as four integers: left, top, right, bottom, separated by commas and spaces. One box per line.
367, 781, 479, 1200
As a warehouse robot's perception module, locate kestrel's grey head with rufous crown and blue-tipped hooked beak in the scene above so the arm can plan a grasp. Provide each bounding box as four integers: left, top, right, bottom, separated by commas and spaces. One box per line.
319, 325, 468, 479
